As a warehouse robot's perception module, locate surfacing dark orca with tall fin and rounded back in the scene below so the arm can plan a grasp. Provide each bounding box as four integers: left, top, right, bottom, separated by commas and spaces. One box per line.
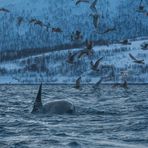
31, 84, 75, 114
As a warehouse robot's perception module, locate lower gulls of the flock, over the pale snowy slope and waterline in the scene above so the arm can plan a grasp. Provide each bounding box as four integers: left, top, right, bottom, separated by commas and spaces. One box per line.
72, 37, 148, 89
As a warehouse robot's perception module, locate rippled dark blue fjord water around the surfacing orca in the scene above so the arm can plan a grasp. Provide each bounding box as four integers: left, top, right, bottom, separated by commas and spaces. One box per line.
0, 85, 148, 148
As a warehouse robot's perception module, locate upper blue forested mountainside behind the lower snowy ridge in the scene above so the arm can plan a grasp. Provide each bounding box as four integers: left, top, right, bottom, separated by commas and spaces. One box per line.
0, 0, 148, 51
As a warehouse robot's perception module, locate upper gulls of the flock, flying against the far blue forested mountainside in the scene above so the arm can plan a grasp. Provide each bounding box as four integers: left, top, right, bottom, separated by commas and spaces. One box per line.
0, 0, 148, 36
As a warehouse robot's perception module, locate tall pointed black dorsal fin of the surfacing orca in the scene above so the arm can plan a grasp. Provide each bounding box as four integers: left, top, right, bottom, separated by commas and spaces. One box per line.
31, 83, 43, 113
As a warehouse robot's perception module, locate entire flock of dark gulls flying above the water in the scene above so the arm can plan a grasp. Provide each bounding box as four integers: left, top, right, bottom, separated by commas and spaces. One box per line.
0, 0, 148, 89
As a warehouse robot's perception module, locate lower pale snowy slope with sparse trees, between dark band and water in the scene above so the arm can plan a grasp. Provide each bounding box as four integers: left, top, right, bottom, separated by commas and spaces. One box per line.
0, 39, 148, 84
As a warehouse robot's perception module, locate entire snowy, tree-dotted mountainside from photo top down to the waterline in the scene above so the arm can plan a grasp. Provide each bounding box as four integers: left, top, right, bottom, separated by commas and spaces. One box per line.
0, 0, 148, 83
